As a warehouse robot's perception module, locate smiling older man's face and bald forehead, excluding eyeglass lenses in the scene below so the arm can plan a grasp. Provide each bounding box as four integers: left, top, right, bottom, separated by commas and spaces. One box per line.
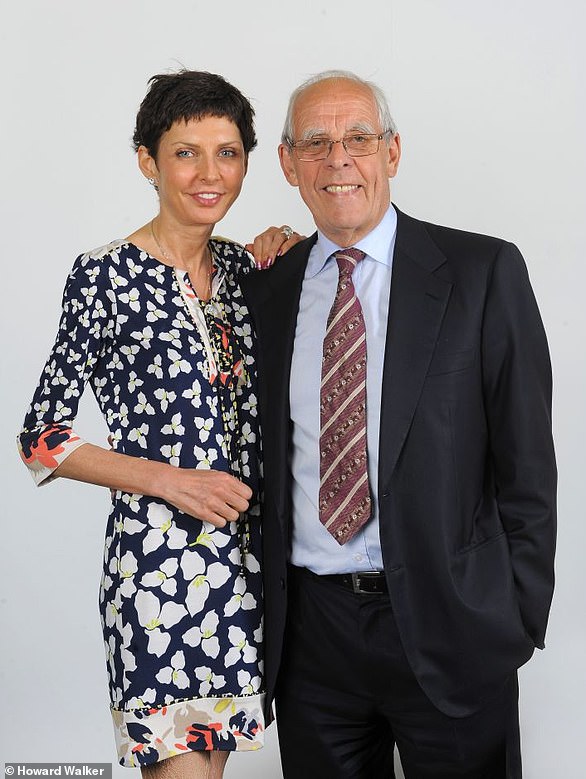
279, 78, 401, 247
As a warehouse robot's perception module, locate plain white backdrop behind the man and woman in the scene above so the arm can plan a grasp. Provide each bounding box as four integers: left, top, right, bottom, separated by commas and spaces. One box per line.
0, 0, 586, 779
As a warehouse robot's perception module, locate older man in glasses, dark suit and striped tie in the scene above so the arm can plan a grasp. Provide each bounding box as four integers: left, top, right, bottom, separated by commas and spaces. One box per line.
238, 71, 556, 779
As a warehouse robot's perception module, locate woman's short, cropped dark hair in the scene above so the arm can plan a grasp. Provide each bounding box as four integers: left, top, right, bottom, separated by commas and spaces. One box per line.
132, 70, 256, 159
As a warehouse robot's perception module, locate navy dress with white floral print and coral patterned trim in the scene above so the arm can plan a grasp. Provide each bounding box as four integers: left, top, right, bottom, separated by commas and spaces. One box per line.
19, 239, 264, 767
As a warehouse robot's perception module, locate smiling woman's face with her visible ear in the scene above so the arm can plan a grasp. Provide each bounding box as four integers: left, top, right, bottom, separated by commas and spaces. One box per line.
138, 116, 246, 227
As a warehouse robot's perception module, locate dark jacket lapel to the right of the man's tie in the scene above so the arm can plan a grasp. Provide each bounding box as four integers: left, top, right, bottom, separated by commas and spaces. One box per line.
379, 209, 452, 496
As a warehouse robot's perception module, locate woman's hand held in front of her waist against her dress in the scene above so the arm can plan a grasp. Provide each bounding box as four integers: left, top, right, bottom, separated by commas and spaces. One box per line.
157, 467, 252, 527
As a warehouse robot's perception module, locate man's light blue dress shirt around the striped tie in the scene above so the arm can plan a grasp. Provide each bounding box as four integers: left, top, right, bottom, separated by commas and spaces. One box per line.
289, 206, 397, 574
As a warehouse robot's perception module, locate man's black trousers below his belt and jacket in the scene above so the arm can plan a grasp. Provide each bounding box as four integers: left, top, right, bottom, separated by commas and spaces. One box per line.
276, 568, 521, 779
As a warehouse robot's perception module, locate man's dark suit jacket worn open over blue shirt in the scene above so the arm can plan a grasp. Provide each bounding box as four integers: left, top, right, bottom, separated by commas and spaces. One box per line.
242, 207, 556, 716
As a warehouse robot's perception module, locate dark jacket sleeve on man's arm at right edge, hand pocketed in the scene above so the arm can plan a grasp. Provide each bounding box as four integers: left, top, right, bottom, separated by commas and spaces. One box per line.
482, 243, 557, 647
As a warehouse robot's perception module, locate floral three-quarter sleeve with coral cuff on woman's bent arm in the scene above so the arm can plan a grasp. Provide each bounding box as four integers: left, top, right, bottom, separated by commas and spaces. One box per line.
17, 251, 115, 485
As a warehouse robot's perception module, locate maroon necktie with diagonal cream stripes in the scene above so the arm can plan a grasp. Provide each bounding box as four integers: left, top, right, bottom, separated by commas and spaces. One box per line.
319, 249, 371, 544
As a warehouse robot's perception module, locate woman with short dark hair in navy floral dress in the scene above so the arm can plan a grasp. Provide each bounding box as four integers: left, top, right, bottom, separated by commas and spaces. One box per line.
19, 71, 295, 779
